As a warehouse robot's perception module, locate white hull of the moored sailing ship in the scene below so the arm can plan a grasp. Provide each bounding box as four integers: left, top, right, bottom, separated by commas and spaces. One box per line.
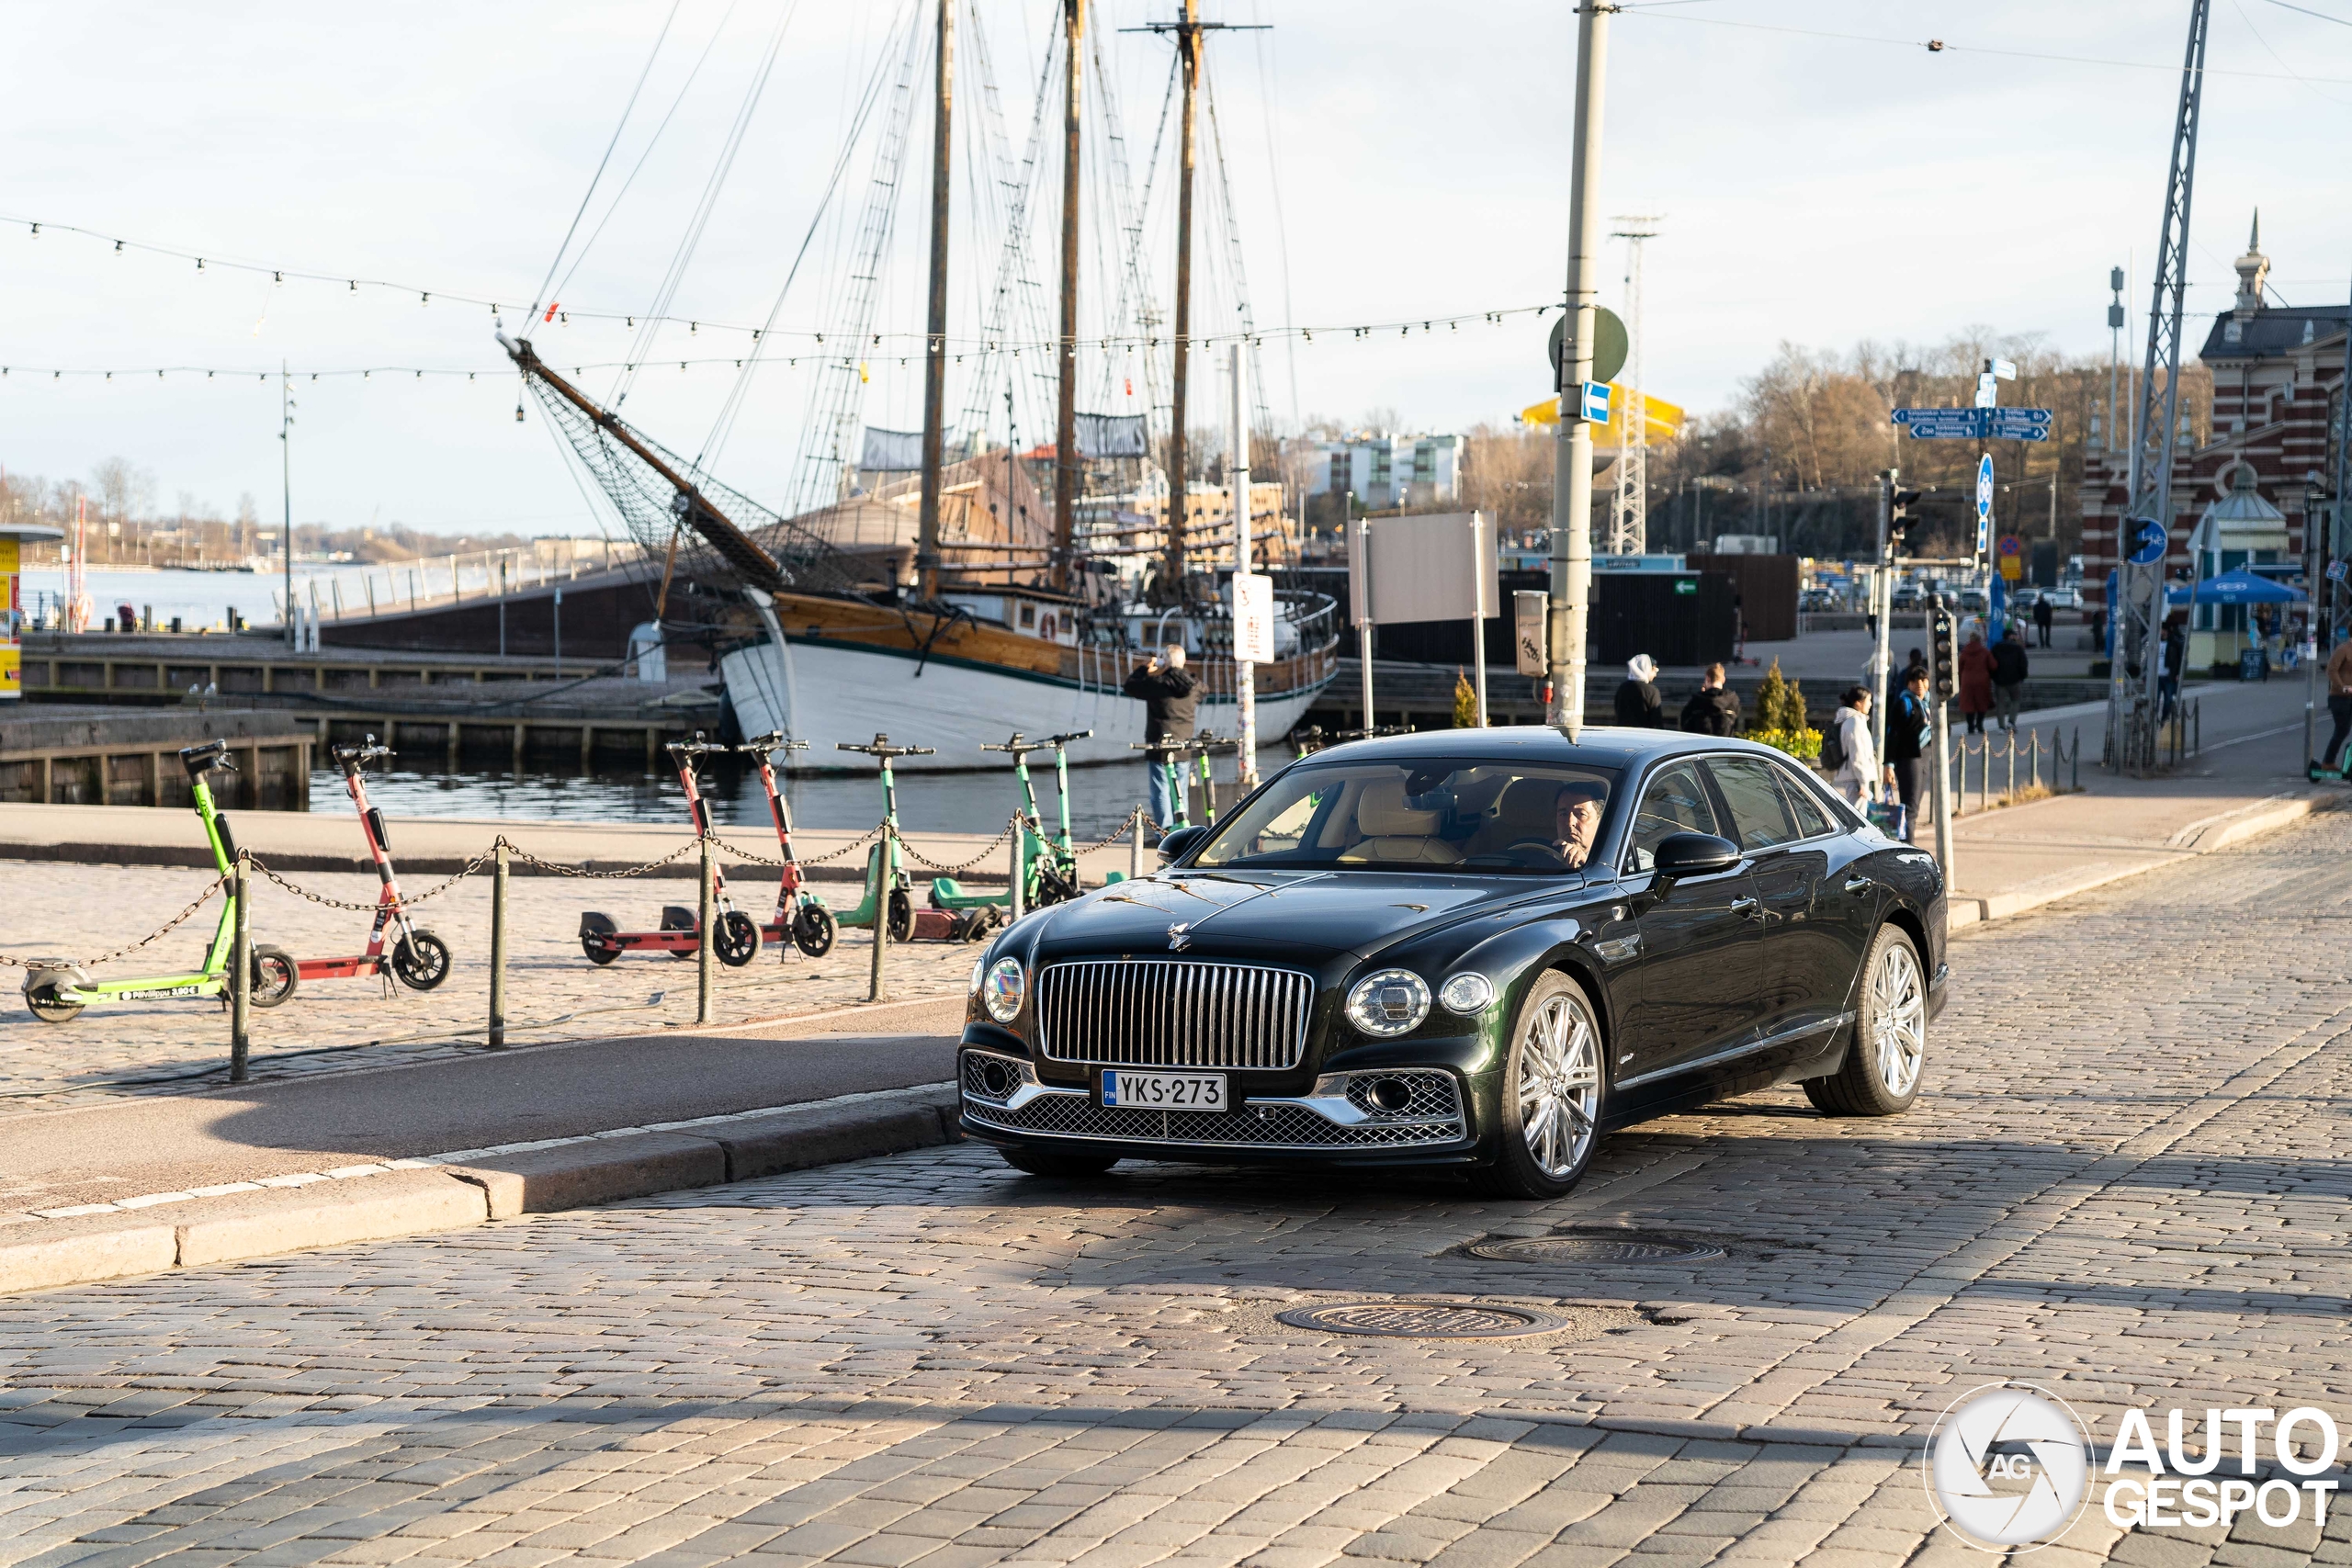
719, 637, 1329, 771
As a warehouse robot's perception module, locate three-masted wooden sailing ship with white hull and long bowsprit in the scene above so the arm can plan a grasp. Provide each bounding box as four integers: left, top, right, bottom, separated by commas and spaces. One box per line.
499, 0, 1339, 769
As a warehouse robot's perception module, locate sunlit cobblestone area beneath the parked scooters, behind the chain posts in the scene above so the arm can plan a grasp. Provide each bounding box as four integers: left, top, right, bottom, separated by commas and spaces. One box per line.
0, 861, 974, 1114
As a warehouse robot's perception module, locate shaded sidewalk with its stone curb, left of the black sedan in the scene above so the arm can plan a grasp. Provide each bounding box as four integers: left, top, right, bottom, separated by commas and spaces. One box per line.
0, 997, 965, 1293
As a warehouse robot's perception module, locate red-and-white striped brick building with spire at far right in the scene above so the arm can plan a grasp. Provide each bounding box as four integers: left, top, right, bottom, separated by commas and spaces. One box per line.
2082, 216, 2352, 665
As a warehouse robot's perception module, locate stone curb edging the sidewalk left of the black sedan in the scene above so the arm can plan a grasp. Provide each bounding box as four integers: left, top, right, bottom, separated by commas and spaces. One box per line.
0, 1090, 959, 1295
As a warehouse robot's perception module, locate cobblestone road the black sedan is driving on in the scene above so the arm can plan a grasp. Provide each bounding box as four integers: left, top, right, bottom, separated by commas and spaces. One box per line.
0, 816, 2352, 1568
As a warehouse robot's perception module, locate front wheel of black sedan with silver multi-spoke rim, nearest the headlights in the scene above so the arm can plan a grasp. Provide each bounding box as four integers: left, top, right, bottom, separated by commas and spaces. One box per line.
1475, 968, 1609, 1201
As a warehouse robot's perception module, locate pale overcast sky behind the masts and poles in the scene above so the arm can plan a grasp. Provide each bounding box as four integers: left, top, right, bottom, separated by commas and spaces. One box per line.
0, 0, 2352, 531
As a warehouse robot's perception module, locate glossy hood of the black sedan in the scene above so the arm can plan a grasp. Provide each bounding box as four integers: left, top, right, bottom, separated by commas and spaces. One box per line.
1033, 870, 1583, 959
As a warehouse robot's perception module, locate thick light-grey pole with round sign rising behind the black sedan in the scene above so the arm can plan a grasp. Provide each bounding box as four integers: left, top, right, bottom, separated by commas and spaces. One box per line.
1552, 0, 1616, 740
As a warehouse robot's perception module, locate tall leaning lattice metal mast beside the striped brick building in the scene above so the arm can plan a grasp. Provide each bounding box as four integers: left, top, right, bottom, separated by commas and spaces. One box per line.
2108, 0, 2213, 771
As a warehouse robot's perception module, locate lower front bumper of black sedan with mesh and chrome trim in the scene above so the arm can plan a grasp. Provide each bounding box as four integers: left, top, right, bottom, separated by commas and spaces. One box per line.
957, 1046, 1473, 1164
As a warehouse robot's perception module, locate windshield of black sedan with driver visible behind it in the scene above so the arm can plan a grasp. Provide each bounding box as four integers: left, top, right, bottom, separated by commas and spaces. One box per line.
1193, 760, 1618, 874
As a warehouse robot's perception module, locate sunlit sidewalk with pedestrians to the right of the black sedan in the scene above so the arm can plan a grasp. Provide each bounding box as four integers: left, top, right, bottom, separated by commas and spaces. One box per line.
1912, 680, 2347, 929
